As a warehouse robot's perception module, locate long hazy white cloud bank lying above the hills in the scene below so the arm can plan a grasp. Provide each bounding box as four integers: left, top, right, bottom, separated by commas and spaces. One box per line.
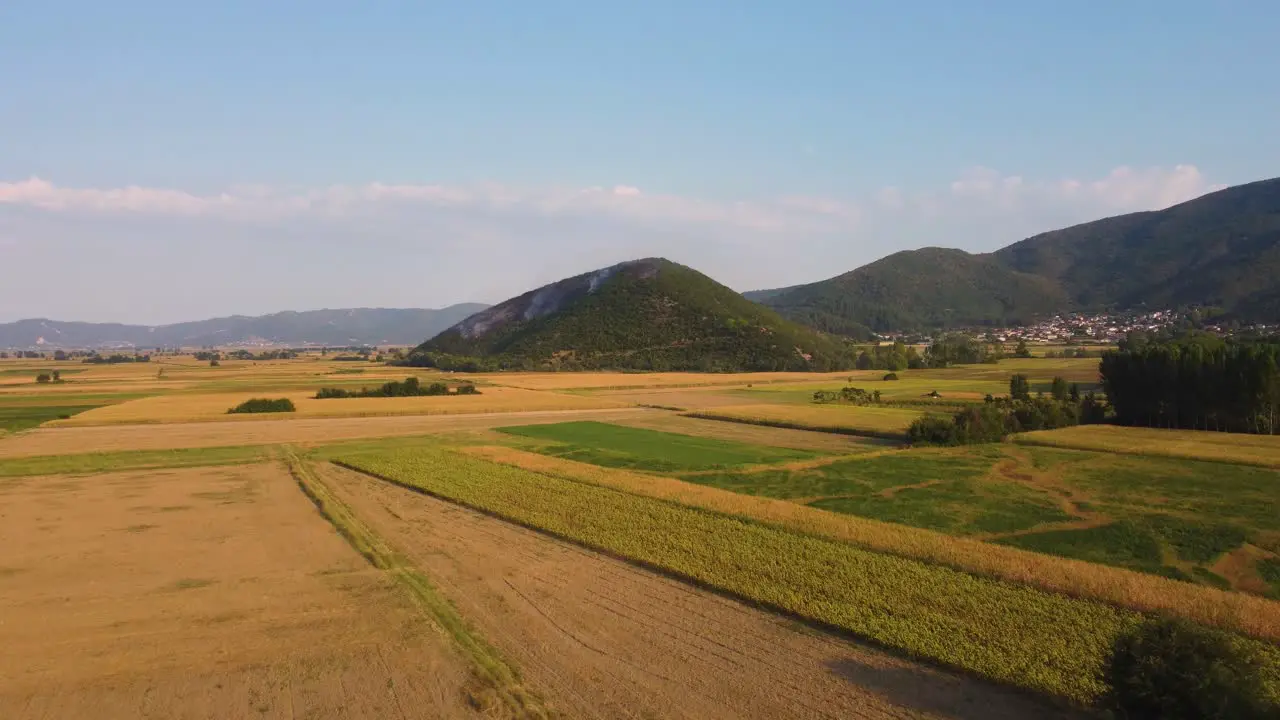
0, 165, 1217, 322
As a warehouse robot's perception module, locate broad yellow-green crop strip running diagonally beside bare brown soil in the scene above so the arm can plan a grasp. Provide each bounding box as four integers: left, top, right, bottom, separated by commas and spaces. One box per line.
338, 448, 1162, 703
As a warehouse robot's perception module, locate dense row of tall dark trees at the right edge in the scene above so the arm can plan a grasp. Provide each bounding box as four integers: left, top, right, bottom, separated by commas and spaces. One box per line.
1100, 336, 1280, 434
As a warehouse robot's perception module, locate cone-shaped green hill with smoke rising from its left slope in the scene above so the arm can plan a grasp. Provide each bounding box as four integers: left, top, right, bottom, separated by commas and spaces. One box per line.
410, 259, 852, 372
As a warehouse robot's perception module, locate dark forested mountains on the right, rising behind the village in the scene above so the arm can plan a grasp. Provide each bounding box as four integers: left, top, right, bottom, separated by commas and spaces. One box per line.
746, 178, 1280, 337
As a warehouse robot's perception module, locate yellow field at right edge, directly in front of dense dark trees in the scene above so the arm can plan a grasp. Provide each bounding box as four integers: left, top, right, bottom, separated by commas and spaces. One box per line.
1014, 425, 1280, 468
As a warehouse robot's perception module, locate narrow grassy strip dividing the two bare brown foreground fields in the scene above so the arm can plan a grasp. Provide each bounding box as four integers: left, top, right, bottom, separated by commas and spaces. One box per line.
284, 448, 549, 717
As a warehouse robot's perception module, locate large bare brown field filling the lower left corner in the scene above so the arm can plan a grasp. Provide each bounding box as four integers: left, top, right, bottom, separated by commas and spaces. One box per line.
0, 465, 468, 720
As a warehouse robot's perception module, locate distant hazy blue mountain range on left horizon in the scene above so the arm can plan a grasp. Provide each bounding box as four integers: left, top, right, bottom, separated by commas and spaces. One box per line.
0, 302, 486, 348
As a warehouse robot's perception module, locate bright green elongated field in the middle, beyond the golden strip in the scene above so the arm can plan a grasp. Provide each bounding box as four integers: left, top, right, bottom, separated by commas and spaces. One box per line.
498, 421, 818, 471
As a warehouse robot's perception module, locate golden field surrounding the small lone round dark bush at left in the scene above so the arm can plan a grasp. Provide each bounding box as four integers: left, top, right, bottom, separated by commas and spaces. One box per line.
51, 387, 627, 427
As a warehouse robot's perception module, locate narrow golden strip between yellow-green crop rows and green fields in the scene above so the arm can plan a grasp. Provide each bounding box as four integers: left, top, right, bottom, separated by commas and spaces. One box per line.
463, 446, 1280, 642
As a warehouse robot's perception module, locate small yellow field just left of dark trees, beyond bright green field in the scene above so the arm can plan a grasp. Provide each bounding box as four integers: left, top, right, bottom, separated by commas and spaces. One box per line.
690, 405, 924, 437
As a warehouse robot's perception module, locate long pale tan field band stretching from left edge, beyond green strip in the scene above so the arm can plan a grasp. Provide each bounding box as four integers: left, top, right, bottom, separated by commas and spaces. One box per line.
0, 409, 669, 457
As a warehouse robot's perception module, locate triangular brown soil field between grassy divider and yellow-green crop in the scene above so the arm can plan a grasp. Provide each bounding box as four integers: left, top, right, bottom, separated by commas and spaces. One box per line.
315, 465, 1080, 720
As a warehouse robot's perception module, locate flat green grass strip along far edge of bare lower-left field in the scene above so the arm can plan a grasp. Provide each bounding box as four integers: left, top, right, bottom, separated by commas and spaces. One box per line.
0, 445, 271, 478
